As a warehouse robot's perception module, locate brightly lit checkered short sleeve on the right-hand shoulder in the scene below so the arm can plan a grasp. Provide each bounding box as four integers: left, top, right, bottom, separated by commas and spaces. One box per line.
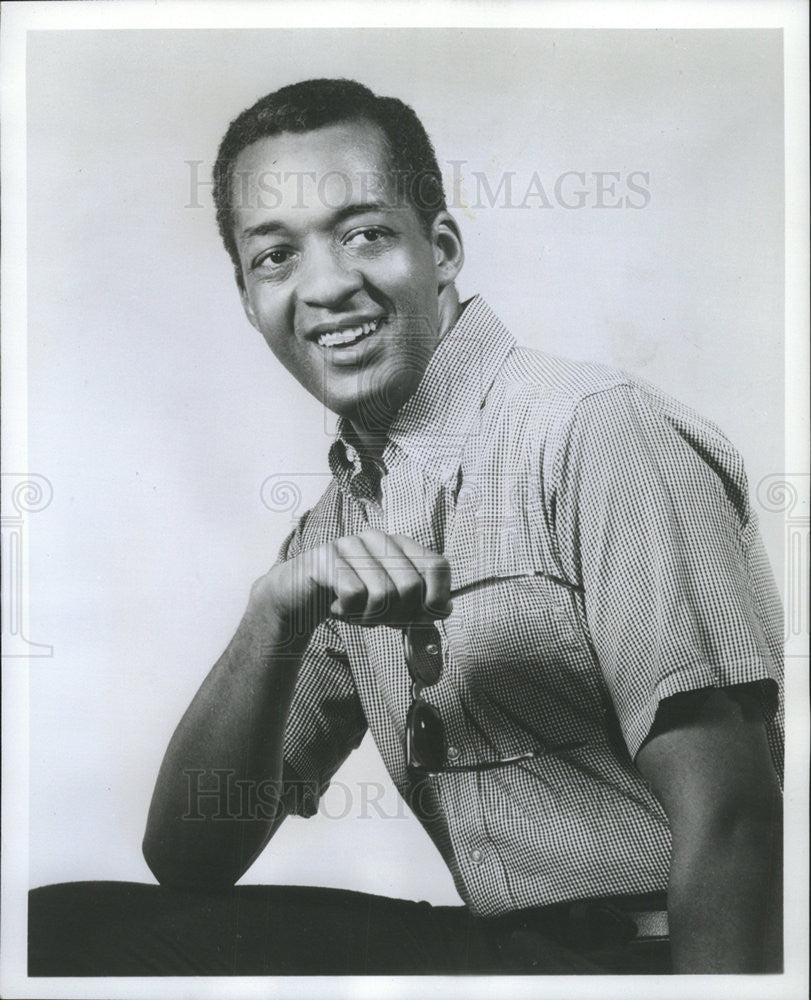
553, 385, 781, 756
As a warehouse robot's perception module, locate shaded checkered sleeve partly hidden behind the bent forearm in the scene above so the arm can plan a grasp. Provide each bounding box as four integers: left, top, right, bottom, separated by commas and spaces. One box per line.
272, 525, 367, 816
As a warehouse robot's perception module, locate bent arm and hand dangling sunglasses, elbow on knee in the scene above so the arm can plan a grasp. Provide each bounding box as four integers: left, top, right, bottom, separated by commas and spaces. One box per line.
143, 531, 450, 889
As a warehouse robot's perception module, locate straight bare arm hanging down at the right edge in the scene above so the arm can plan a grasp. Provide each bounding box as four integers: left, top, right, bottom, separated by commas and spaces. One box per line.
636, 687, 782, 973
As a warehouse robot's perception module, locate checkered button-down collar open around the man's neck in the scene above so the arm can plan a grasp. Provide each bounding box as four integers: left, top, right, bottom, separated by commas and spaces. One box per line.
329, 295, 515, 481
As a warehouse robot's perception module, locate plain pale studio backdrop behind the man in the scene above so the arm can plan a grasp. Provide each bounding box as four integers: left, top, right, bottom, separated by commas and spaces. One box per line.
27, 29, 784, 903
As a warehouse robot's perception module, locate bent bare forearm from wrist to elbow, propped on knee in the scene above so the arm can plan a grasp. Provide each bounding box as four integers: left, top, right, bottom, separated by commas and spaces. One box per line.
144, 613, 307, 887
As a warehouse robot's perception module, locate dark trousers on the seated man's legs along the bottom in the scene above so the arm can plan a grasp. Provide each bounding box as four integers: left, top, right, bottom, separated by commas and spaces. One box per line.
28, 882, 670, 976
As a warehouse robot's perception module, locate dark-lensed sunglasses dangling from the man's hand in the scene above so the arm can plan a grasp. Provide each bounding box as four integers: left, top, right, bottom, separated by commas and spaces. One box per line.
403, 623, 585, 777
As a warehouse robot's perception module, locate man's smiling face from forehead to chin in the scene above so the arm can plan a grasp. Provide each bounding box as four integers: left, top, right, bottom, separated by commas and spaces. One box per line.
234, 122, 454, 429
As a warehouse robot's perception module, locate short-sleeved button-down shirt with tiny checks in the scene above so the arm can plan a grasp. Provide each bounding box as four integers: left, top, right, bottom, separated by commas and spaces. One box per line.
272, 298, 783, 915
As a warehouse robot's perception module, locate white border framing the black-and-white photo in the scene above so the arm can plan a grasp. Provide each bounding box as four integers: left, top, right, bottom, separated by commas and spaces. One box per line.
0, 0, 809, 1000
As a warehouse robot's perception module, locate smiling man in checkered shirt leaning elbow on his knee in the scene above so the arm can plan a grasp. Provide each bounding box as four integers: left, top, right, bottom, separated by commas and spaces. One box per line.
30, 80, 782, 975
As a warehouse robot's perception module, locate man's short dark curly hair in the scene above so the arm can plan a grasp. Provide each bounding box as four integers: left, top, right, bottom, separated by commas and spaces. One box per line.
214, 79, 447, 285
